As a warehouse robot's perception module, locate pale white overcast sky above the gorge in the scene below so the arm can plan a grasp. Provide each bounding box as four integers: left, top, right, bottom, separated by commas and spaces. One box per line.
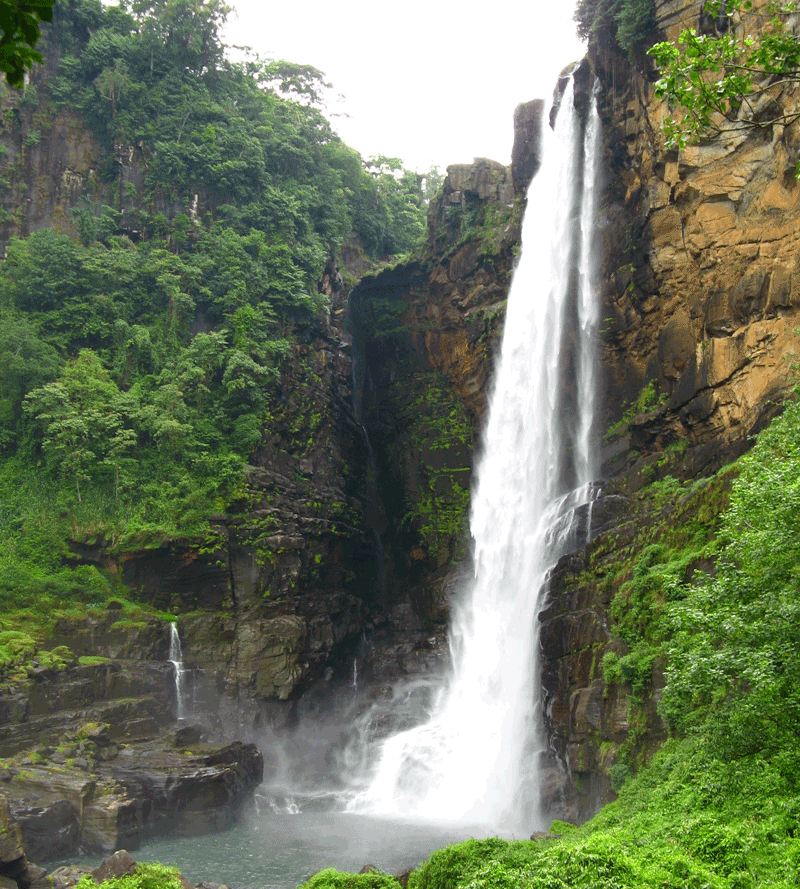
224, 0, 584, 172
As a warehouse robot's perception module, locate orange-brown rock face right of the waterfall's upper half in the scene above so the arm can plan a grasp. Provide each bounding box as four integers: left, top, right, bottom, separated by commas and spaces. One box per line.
593, 0, 800, 458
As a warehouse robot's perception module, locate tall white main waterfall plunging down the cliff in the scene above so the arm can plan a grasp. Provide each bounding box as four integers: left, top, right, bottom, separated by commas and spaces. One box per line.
349, 78, 599, 831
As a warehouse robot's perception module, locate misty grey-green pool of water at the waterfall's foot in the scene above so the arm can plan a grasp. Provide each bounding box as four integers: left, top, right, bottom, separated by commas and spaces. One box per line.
119, 810, 496, 889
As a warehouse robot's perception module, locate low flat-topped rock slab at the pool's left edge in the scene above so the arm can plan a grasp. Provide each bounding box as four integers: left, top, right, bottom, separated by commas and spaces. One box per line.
0, 724, 263, 861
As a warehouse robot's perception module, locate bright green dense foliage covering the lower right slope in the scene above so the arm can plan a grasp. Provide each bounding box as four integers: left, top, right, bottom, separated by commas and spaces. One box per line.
305, 401, 800, 889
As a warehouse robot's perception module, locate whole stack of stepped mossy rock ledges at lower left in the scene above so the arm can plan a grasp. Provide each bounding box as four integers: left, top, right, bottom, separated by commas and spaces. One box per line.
0, 603, 263, 860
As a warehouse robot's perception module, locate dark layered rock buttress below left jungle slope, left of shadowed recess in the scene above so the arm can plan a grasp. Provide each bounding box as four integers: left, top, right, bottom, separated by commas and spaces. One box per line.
53, 310, 383, 731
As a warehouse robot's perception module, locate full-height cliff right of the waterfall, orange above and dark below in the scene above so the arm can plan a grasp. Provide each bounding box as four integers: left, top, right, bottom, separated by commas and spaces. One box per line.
542, 0, 800, 818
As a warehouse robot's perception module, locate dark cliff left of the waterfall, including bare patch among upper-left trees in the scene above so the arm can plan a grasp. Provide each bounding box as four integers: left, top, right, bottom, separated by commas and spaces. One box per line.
0, 40, 540, 764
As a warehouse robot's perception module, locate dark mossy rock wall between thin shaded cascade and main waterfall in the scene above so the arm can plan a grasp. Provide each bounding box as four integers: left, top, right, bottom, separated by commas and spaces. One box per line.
350, 149, 524, 616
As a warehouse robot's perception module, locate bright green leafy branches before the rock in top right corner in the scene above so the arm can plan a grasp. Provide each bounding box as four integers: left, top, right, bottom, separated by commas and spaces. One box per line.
649, 0, 800, 148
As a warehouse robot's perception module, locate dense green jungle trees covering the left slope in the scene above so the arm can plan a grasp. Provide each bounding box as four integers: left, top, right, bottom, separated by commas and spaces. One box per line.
0, 0, 432, 624
